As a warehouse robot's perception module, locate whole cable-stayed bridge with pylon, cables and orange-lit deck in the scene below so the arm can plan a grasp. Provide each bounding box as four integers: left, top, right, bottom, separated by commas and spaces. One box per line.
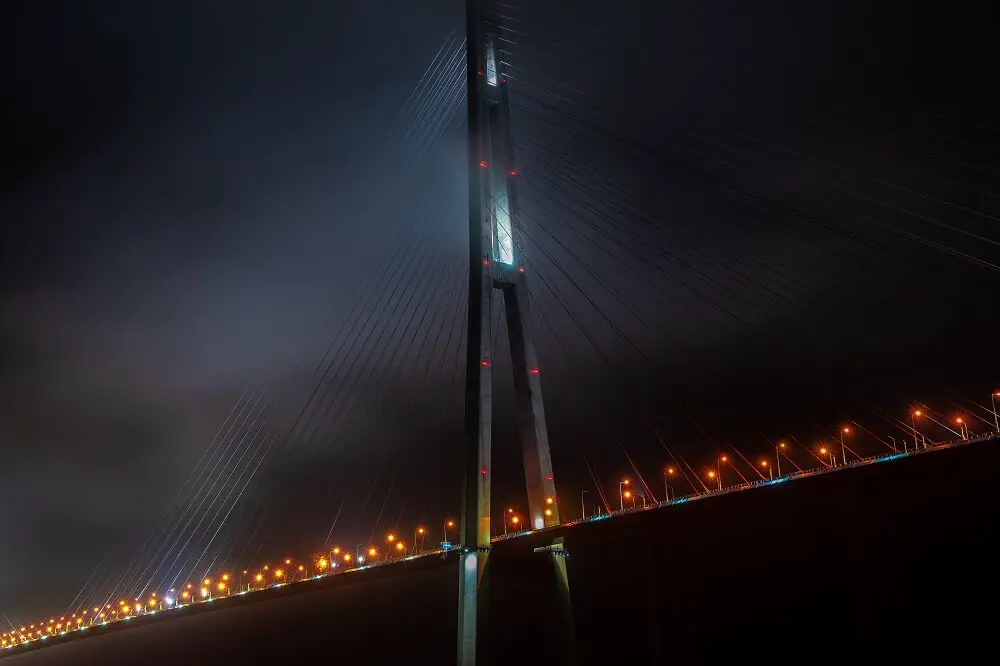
3, 3, 1000, 663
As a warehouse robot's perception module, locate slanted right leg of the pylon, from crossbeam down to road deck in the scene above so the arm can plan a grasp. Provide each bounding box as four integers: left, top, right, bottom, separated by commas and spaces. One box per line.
502, 277, 559, 529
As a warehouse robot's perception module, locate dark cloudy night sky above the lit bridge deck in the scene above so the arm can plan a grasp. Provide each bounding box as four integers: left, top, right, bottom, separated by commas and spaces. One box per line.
0, 0, 1000, 622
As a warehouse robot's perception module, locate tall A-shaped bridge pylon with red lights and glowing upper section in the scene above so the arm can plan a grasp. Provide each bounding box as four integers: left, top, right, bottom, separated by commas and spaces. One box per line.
458, 0, 559, 666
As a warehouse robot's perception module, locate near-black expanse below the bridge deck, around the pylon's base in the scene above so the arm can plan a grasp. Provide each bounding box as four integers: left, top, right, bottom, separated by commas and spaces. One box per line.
0, 440, 1000, 666
